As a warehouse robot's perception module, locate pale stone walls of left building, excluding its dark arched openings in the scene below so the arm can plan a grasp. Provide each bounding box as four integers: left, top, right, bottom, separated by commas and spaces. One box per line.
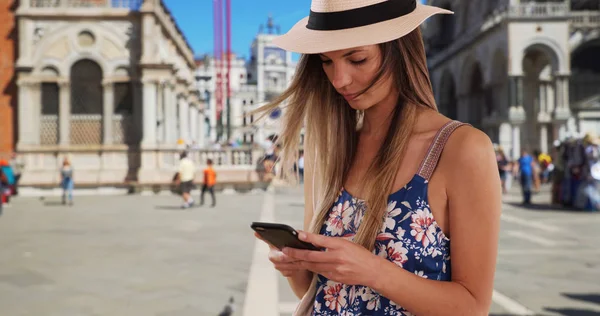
17, 0, 202, 185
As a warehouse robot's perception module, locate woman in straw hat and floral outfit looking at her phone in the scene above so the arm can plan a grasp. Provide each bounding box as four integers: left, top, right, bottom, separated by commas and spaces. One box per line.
253, 0, 501, 315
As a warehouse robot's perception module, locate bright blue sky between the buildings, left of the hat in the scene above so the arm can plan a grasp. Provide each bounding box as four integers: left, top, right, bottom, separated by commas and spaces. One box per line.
164, 0, 310, 58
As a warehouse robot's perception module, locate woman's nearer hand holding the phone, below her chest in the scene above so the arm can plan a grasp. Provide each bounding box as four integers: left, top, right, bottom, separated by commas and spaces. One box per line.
283, 231, 383, 287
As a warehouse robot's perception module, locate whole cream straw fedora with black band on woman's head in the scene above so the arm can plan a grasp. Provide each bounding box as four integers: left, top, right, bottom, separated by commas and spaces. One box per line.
273, 0, 453, 54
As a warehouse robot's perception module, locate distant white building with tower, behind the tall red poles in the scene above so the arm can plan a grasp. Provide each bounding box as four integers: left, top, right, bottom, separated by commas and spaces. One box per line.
196, 20, 296, 146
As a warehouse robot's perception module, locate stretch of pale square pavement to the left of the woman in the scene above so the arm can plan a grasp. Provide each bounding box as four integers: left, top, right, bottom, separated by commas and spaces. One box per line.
0, 190, 263, 316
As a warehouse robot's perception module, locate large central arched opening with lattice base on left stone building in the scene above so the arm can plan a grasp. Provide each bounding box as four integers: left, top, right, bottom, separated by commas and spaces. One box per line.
70, 59, 104, 145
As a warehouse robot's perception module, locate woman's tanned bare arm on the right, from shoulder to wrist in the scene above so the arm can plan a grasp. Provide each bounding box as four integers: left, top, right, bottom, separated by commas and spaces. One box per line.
373, 127, 502, 316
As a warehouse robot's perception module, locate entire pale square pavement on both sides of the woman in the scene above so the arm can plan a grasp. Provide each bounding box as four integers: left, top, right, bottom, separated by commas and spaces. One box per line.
0, 188, 600, 316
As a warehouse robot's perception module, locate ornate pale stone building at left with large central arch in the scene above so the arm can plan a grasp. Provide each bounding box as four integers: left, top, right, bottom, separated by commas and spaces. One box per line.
16, 0, 204, 185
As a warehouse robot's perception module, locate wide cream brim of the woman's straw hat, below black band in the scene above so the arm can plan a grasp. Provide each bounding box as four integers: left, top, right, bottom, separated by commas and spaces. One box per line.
273, 4, 454, 54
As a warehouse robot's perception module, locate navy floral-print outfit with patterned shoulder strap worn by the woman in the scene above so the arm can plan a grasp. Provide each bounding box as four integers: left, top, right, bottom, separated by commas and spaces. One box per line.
313, 121, 465, 316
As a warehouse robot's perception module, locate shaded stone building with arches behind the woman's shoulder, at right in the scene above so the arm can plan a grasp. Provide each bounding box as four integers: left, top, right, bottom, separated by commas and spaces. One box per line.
424, 0, 600, 158
